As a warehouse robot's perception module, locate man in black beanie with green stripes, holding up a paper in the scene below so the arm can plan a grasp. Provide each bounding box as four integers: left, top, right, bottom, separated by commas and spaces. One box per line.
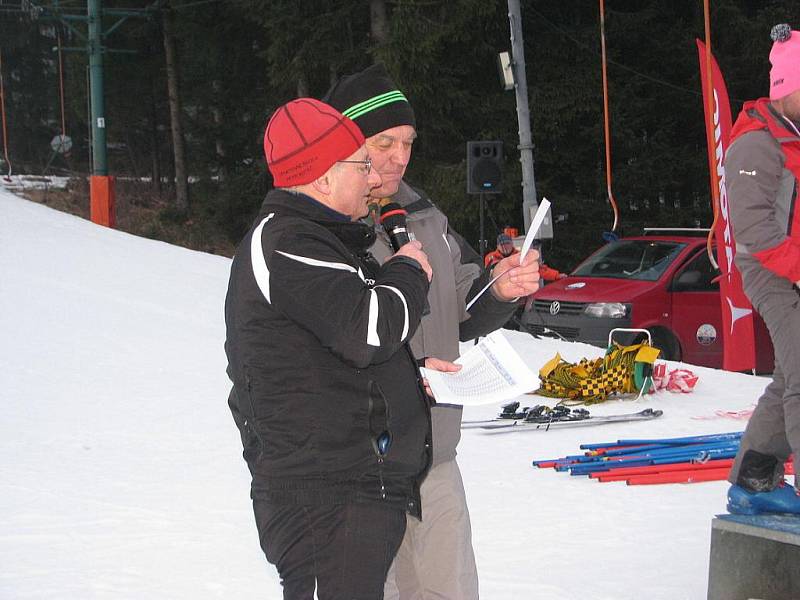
325, 64, 539, 600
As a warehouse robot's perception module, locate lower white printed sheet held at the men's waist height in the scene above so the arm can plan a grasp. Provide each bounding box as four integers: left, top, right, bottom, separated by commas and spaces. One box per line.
421, 330, 539, 406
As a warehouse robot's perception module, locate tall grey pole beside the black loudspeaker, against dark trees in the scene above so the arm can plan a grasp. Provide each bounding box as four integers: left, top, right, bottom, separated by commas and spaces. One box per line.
508, 0, 542, 237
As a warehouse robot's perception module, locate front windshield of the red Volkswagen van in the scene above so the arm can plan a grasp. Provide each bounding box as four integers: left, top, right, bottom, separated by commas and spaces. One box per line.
572, 240, 686, 281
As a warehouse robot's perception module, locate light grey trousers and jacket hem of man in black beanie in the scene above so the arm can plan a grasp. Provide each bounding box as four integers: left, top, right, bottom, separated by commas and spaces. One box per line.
384, 404, 478, 600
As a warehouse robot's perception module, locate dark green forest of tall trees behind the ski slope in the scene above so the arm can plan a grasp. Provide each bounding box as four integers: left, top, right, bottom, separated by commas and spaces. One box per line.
0, 0, 800, 269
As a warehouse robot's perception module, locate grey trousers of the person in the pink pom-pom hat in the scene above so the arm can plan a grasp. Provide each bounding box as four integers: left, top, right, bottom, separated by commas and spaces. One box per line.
729, 286, 800, 489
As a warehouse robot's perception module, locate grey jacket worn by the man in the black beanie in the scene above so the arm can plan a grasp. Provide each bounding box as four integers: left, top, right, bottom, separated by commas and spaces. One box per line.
370, 182, 515, 465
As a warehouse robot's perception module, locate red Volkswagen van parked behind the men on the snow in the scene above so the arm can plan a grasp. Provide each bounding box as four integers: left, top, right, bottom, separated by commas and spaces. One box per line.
521, 230, 774, 373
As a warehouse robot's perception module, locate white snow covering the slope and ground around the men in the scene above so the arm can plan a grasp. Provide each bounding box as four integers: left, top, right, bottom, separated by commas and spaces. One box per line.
0, 189, 765, 600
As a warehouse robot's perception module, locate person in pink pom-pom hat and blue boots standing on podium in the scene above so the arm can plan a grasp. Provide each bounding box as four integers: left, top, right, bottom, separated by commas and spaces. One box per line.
725, 25, 800, 514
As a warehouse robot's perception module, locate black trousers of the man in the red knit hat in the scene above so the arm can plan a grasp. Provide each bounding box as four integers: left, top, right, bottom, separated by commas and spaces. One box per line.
253, 500, 406, 600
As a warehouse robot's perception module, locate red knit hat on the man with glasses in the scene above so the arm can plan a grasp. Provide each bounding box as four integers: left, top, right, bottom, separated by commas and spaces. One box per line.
264, 98, 364, 187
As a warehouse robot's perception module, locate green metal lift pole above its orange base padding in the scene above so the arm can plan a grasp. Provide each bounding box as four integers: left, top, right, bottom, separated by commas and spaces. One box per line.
86, 0, 108, 175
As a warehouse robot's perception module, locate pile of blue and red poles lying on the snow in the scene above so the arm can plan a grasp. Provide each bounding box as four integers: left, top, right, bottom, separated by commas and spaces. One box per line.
533, 432, 793, 485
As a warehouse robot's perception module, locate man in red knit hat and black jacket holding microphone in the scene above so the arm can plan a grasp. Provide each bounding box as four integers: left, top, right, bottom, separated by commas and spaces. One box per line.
225, 98, 438, 600
